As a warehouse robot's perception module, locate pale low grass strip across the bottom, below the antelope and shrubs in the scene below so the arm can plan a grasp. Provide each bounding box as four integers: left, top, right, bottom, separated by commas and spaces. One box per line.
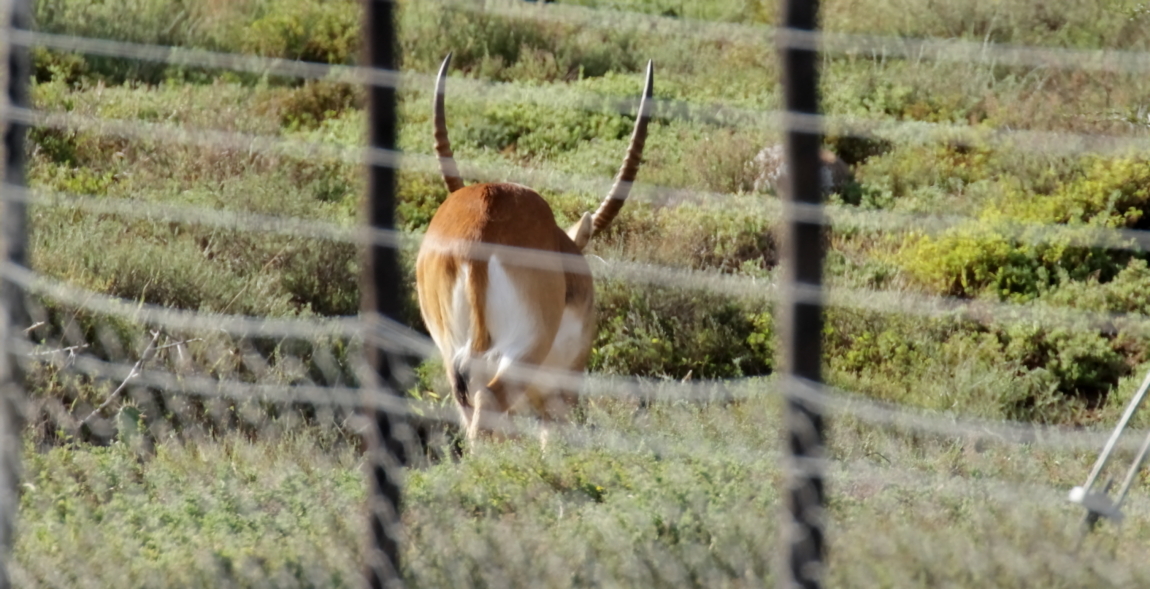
14, 382, 1150, 588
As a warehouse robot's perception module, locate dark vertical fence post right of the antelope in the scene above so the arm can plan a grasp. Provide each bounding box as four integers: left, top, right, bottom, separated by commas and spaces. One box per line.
777, 0, 827, 589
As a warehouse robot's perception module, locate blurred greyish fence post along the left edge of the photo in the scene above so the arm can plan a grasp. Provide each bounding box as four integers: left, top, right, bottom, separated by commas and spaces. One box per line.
0, 0, 31, 589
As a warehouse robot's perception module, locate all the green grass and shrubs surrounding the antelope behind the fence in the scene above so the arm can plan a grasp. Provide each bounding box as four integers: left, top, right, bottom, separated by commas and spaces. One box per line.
14, 0, 1150, 587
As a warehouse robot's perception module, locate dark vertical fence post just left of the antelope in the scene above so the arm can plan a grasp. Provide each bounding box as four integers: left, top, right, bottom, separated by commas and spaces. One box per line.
360, 0, 404, 589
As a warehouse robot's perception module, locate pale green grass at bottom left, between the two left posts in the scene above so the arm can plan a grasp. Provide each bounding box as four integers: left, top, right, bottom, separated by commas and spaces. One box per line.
12, 431, 365, 587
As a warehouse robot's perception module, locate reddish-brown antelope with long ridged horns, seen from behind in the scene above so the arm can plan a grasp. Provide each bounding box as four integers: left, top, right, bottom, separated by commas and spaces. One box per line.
415, 54, 653, 442
